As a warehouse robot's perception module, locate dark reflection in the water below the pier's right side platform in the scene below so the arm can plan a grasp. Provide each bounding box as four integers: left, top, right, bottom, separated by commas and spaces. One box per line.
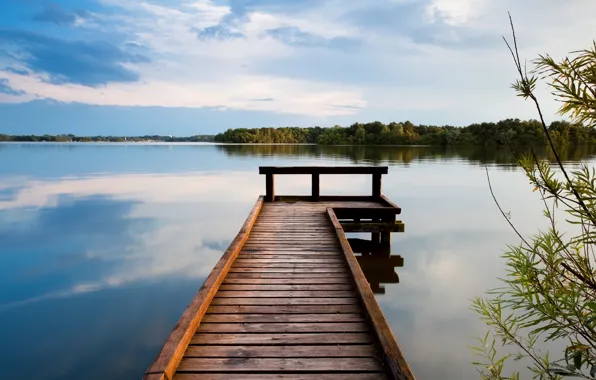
348, 239, 404, 294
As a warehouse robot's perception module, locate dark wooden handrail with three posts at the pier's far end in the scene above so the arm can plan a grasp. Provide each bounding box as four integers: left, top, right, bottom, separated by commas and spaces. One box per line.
259, 166, 389, 202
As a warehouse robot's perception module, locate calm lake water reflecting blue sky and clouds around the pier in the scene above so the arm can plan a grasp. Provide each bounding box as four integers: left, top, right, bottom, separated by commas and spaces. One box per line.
0, 144, 593, 380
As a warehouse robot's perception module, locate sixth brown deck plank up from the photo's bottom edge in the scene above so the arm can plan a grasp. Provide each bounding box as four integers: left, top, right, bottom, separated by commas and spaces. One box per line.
201, 314, 364, 326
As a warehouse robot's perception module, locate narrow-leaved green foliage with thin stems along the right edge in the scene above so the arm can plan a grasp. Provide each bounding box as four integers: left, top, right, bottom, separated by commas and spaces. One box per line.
472, 16, 596, 379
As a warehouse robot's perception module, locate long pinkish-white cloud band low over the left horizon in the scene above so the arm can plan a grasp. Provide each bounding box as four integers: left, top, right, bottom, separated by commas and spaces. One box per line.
0, 71, 366, 116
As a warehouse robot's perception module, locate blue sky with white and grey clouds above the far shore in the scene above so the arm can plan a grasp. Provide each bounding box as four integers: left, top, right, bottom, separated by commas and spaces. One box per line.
0, 0, 596, 135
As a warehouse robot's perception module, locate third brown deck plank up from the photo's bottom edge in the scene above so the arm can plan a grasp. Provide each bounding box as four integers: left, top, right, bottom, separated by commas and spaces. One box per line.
184, 344, 377, 358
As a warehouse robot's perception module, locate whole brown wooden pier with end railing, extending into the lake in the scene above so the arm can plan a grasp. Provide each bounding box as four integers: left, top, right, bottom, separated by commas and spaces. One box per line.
144, 166, 414, 380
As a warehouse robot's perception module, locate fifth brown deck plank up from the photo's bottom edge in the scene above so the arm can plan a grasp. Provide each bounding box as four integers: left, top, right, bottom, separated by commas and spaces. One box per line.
197, 322, 370, 334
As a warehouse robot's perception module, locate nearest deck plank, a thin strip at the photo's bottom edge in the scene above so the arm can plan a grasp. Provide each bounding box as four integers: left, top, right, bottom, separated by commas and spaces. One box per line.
174, 372, 387, 380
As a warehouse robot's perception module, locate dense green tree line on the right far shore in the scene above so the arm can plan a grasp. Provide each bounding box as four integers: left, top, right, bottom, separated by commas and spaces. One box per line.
214, 119, 596, 146
